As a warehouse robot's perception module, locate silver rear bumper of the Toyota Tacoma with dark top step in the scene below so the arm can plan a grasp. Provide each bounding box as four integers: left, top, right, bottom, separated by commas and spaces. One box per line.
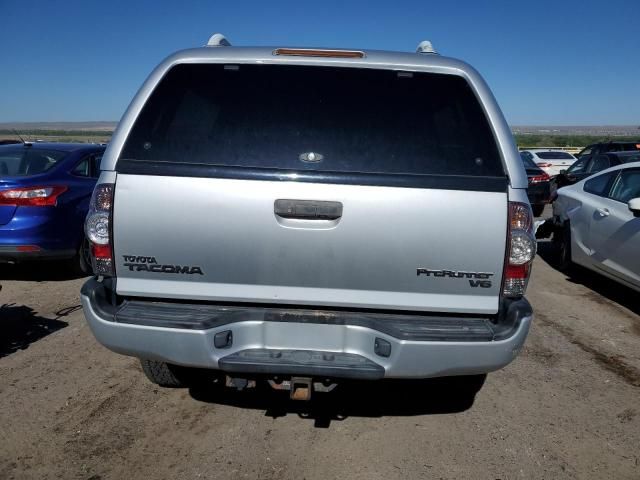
81, 279, 533, 379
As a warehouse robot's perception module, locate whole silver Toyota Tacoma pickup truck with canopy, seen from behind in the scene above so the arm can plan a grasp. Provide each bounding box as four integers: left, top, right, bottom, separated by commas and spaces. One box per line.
82, 34, 536, 398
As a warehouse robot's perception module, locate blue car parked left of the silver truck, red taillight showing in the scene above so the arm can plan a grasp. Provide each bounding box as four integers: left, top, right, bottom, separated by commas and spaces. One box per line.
0, 142, 105, 273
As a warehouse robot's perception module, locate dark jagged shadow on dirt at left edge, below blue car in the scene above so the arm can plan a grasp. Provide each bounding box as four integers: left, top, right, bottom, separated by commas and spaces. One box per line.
0, 304, 80, 358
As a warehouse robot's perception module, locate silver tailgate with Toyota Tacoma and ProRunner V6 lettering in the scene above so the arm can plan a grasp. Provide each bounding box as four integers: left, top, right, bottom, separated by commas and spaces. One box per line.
114, 175, 507, 313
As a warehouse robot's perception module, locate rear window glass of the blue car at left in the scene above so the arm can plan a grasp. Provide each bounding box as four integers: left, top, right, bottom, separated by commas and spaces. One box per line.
0, 145, 67, 177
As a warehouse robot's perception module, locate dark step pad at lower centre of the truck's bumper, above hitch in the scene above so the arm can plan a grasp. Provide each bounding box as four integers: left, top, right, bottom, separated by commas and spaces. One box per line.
218, 348, 385, 380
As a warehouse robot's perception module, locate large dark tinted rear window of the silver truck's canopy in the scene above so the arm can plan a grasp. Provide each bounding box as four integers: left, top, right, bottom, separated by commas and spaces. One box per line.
121, 65, 504, 176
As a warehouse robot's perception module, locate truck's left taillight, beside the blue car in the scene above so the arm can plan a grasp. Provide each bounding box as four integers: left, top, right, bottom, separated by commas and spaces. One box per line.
84, 183, 115, 276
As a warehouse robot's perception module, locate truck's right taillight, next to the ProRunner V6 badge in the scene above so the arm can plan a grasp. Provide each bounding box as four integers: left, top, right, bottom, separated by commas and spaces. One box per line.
502, 202, 537, 298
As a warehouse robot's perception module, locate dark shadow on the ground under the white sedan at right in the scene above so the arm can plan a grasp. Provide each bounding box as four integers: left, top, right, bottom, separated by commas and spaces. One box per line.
538, 241, 640, 315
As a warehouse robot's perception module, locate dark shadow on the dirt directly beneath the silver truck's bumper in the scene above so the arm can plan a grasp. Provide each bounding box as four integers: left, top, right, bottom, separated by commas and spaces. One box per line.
189, 375, 486, 428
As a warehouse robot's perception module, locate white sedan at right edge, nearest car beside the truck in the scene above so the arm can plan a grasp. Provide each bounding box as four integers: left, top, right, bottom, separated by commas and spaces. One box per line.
553, 162, 640, 291
